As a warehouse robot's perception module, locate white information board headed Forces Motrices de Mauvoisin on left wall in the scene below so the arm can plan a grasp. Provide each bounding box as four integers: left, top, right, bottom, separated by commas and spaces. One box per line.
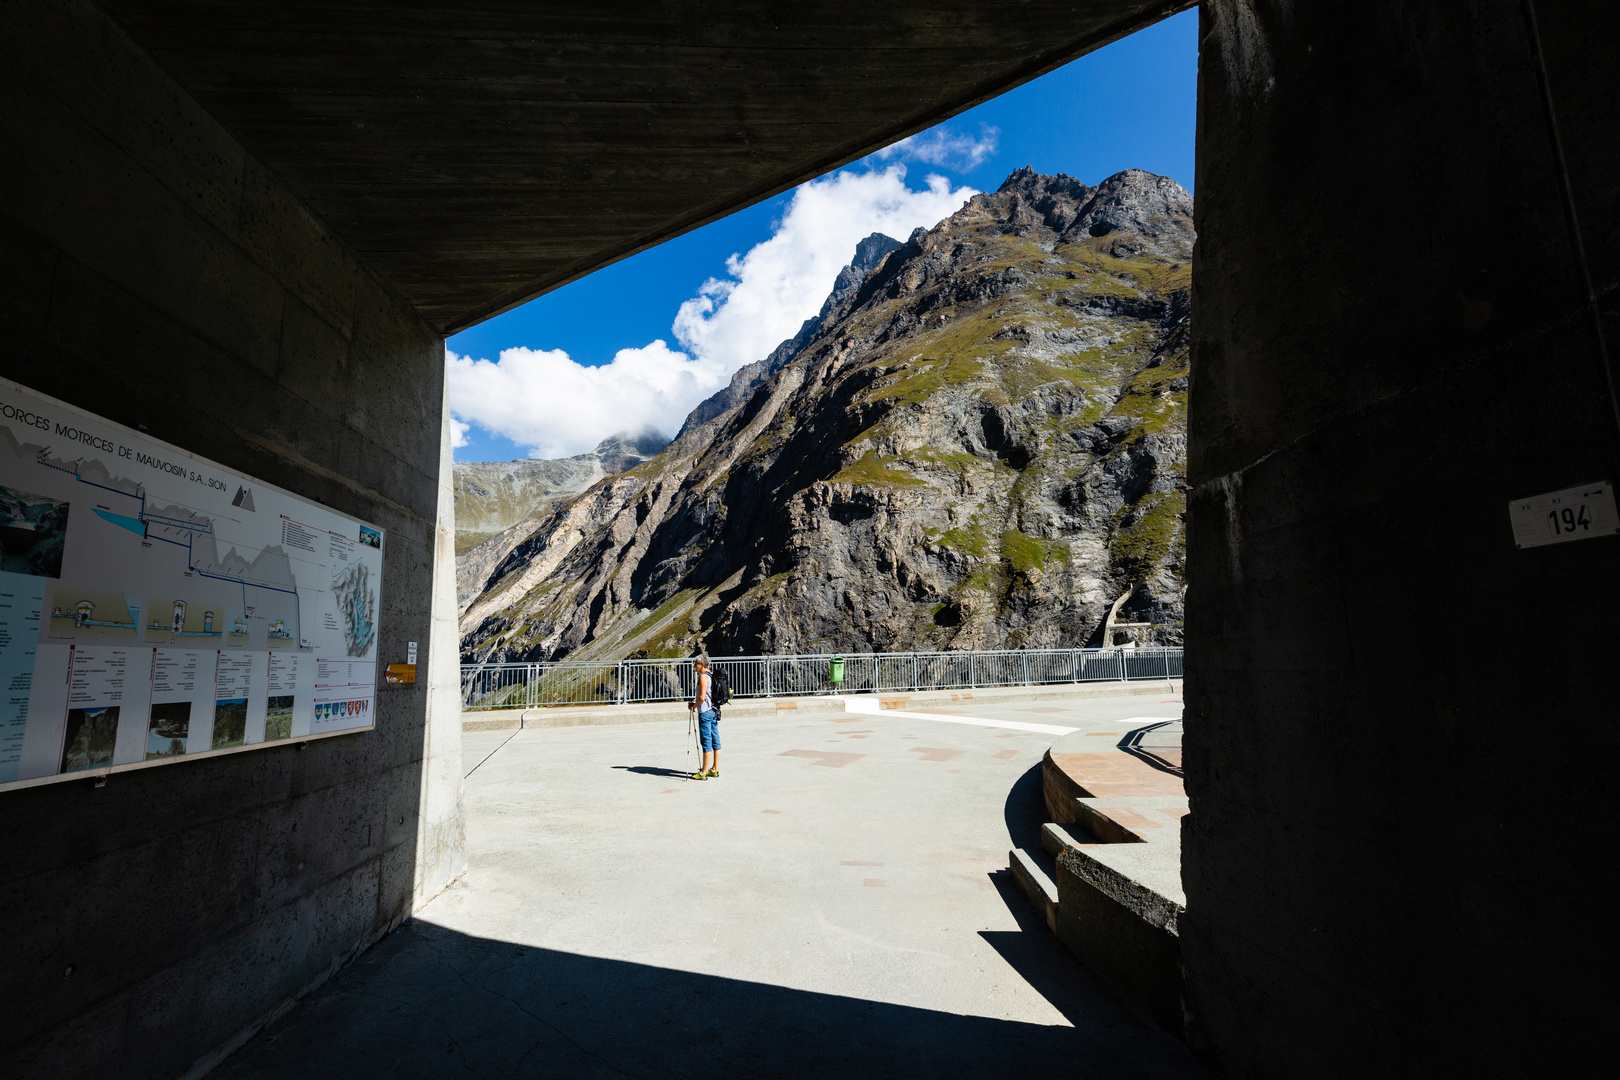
0, 379, 384, 790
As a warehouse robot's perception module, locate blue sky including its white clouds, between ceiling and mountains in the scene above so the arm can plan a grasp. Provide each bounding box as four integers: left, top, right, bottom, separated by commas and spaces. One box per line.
447, 11, 1197, 461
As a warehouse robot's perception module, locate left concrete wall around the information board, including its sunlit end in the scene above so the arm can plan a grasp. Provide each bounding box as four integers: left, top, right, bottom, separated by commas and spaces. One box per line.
0, 0, 465, 1077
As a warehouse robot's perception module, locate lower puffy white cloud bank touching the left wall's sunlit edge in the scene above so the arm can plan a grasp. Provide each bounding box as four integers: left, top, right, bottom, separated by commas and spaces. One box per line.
446, 340, 731, 458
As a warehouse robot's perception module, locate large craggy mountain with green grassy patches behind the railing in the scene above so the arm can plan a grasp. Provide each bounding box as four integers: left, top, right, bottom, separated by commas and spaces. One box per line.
462, 168, 1194, 661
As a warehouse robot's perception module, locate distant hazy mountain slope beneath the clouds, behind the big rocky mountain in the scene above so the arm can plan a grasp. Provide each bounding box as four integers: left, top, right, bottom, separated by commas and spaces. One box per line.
454, 429, 669, 607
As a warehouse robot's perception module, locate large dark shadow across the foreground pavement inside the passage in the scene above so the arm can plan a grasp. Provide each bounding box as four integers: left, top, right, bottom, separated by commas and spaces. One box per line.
212, 920, 1204, 1080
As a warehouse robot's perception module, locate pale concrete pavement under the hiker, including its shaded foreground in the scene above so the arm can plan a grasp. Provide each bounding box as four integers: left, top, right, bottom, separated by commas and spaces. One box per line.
215, 695, 1205, 1080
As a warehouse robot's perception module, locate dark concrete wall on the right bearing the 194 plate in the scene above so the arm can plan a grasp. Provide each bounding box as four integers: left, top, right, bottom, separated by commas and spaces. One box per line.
1181, 0, 1620, 1077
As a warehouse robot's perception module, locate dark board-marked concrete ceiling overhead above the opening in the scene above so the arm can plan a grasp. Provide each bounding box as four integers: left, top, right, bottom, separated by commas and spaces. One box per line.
102, 0, 1191, 334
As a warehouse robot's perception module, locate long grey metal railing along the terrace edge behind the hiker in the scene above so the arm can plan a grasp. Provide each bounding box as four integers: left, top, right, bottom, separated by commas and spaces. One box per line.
462, 646, 1181, 709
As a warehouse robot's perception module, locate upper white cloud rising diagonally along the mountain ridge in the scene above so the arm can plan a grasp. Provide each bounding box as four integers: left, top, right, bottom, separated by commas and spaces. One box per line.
676, 165, 977, 371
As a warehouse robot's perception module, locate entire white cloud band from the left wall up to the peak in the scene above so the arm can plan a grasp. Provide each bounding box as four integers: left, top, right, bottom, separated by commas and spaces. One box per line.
446, 164, 977, 458
